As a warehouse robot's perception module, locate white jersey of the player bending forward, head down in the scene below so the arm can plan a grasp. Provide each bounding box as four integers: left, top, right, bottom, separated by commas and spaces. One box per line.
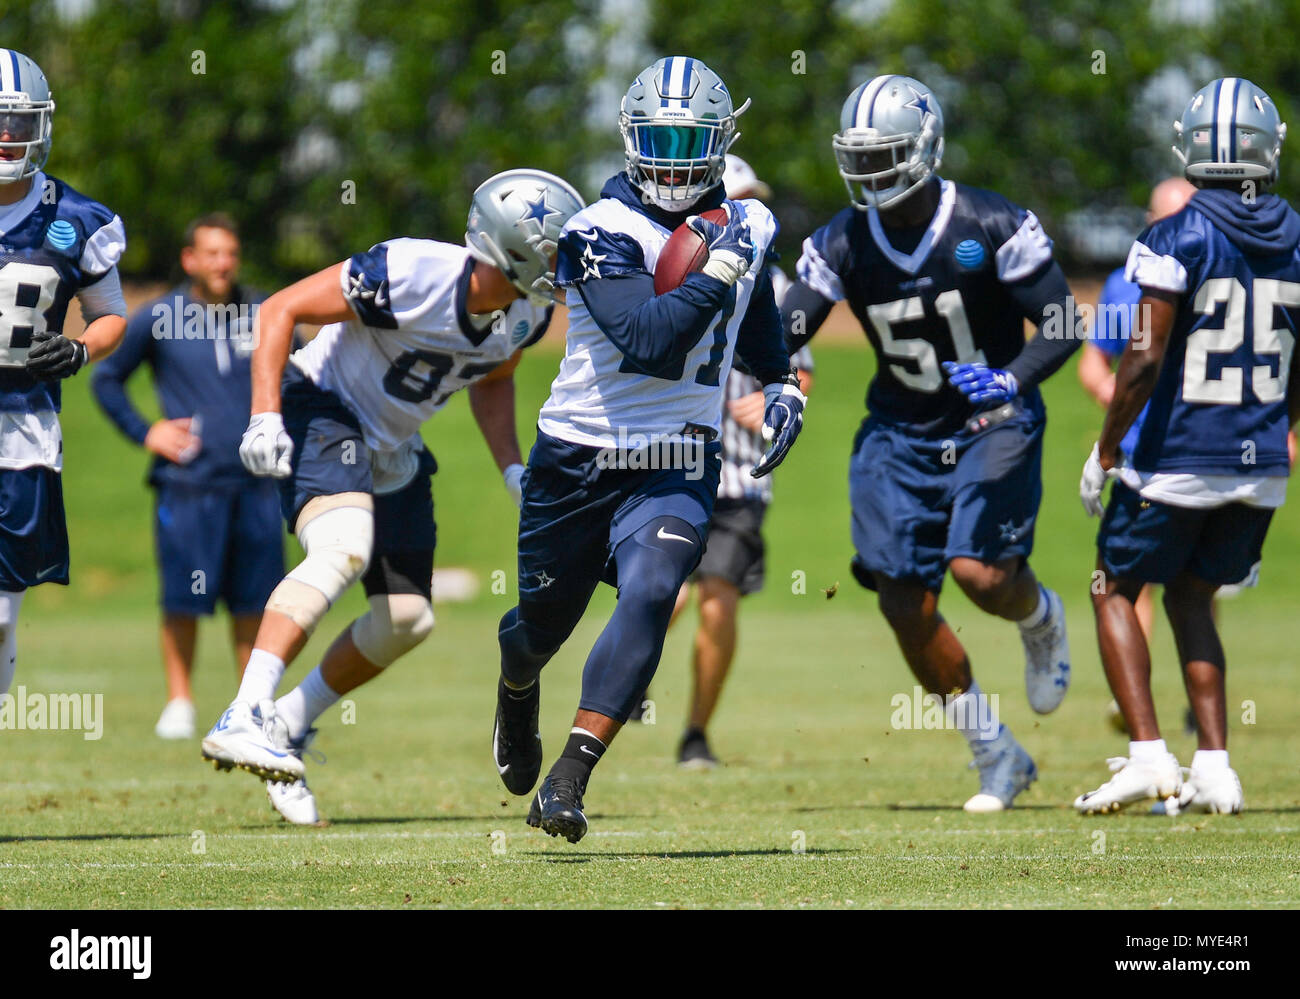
290, 239, 551, 451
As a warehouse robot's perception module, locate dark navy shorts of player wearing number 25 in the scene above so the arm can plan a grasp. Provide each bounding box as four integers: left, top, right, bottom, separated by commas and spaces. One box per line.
1097, 483, 1275, 587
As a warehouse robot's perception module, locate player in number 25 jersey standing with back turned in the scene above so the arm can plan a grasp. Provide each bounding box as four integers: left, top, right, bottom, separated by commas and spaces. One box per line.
1074, 77, 1300, 813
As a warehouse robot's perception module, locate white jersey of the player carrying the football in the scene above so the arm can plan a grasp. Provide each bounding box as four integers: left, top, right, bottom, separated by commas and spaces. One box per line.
537, 198, 776, 447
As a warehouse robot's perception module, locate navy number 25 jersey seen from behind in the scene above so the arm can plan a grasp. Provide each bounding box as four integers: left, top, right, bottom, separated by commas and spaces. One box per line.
1126, 190, 1300, 476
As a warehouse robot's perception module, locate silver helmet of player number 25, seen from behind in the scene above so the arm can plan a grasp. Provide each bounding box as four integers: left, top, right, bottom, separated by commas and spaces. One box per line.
1174, 77, 1287, 185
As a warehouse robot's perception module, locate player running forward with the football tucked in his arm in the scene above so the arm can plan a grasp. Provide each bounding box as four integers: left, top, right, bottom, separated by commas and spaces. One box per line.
493, 56, 805, 843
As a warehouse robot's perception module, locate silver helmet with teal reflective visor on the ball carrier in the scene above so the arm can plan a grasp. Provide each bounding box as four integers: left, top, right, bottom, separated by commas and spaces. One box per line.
619, 56, 749, 212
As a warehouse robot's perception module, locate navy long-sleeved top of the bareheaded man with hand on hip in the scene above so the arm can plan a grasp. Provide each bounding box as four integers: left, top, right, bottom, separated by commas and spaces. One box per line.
91, 285, 267, 485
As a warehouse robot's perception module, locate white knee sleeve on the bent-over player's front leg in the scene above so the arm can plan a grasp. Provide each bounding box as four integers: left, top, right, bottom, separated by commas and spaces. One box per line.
267, 493, 374, 635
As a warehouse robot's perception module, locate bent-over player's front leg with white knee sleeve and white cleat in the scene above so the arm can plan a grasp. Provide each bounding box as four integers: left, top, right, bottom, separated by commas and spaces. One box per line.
203, 379, 374, 782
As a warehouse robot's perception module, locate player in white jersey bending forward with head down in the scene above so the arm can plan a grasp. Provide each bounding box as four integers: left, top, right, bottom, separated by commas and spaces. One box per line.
203, 169, 582, 825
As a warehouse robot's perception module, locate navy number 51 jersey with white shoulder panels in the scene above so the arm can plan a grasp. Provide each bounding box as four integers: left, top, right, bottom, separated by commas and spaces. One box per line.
798, 181, 1052, 436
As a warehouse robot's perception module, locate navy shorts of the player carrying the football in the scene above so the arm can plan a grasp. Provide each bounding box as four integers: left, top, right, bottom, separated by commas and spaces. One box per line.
519, 431, 722, 601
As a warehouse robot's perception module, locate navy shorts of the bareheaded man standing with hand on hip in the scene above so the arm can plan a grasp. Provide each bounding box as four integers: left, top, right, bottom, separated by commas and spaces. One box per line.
153, 479, 285, 617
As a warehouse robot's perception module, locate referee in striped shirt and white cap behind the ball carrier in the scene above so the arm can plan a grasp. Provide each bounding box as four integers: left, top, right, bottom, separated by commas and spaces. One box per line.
650, 153, 813, 770
